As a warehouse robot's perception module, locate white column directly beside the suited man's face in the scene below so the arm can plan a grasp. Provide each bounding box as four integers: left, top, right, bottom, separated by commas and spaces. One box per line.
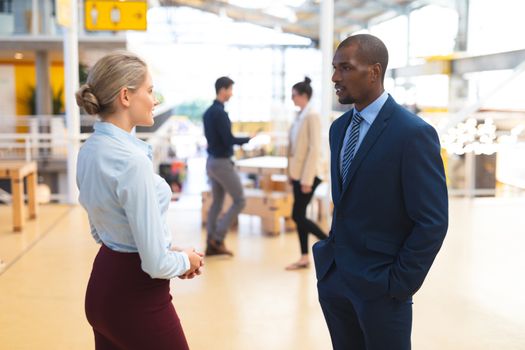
319, 0, 334, 227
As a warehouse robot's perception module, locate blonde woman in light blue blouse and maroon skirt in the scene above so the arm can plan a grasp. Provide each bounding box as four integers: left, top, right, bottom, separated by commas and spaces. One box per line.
76, 52, 202, 349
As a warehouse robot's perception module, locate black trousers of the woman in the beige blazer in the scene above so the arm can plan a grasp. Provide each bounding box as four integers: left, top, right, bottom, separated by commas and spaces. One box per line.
292, 177, 328, 255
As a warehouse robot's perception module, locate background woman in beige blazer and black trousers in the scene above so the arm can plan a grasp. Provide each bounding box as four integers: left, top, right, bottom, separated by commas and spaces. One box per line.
286, 77, 327, 270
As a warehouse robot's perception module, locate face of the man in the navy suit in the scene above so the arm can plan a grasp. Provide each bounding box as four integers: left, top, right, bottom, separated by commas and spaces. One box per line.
332, 44, 372, 104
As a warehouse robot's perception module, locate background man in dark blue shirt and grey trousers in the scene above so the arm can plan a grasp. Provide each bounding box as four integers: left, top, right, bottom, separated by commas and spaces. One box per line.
203, 77, 250, 256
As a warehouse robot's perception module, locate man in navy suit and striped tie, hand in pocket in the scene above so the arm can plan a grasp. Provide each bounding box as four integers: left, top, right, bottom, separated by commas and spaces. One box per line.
313, 34, 448, 350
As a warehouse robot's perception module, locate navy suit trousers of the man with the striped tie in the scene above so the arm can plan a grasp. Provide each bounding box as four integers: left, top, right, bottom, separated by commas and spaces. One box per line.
317, 263, 412, 350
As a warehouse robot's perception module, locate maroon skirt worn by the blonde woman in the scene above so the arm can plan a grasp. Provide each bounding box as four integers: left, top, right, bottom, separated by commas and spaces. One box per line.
85, 245, 188, 350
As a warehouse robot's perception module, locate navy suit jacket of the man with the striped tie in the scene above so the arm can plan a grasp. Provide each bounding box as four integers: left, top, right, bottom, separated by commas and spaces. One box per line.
313, 96, 448, 300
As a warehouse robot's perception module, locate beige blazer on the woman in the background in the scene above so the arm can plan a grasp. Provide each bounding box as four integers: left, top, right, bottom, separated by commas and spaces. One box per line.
288, 111, 321, 186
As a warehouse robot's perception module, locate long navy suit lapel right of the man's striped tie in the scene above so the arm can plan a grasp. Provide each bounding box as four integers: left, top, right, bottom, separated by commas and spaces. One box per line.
340, 96, 394, 197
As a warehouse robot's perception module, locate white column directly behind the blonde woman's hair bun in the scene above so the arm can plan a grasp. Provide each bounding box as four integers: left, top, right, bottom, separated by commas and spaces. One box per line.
64, 0, 80, 204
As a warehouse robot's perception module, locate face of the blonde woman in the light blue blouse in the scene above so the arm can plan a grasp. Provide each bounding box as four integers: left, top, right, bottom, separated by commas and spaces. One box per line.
129, 72, 159, 126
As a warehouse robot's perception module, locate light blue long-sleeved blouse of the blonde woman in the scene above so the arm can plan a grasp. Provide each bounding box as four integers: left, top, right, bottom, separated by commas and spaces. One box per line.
77, 122, 190, 279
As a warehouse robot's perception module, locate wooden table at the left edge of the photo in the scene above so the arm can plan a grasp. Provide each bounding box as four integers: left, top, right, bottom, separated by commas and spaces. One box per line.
0, 161, 37, 232
